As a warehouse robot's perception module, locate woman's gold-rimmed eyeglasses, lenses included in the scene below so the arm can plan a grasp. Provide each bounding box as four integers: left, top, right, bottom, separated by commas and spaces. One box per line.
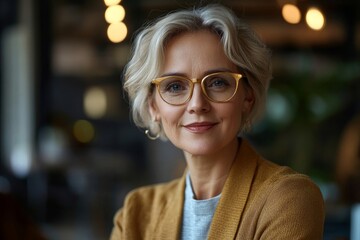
151, 72, 245, 106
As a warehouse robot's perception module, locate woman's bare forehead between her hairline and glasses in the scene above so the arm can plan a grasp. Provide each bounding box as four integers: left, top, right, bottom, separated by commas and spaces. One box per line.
162, 30, 236, 77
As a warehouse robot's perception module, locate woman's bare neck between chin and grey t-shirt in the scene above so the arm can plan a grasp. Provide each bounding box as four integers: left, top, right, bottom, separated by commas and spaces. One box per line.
185, 139, 238, 200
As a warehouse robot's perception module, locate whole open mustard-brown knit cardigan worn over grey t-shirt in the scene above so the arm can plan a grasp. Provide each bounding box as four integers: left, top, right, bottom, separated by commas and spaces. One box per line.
111, 140, 324, 240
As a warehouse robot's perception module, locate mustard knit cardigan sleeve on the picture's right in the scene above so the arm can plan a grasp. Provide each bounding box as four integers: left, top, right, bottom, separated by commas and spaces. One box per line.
254, 174, 324, 240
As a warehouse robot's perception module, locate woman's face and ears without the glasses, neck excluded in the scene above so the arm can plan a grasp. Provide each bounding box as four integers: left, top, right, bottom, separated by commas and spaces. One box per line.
150, 30, 254, 155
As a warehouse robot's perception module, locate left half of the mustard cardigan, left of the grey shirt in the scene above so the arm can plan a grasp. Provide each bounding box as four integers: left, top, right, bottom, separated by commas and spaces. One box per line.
110, 174, 185, 240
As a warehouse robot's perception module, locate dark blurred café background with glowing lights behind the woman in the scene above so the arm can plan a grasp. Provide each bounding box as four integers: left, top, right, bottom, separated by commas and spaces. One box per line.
0, 0, 360, 240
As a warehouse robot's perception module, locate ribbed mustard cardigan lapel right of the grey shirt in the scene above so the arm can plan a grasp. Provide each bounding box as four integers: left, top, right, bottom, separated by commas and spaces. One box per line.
208, 140, 258, 239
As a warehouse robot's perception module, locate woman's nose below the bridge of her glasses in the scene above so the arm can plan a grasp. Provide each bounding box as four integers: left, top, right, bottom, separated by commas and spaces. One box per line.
187, 83, 210, 113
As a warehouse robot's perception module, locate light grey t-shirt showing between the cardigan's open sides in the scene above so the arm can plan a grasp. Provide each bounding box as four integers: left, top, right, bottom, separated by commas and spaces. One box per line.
181, 174, 221, 240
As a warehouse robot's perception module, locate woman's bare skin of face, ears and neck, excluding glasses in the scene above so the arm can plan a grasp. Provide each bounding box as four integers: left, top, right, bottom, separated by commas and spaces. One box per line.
149, 30, 254, 199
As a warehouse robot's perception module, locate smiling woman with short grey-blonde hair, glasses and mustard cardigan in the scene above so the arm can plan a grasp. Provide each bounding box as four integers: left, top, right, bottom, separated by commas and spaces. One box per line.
111, 5, 324, 240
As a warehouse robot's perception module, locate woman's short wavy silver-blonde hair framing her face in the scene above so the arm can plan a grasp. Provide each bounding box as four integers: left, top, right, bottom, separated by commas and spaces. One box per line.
124, 4, 272, 137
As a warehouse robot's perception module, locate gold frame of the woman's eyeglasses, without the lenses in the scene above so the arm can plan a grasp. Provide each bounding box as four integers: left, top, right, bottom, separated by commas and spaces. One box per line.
151, 72, 245, 106
